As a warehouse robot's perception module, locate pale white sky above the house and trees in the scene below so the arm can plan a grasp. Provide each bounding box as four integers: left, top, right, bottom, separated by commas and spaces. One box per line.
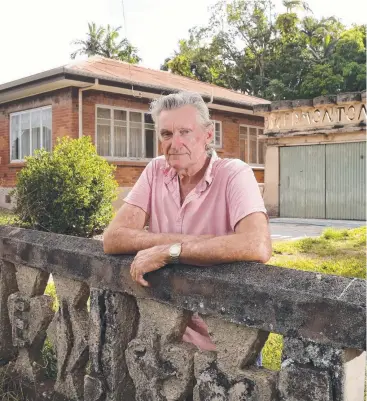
0, 0, 367, 84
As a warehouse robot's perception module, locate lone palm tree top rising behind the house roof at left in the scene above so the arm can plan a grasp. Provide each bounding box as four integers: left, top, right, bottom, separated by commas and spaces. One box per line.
70, 22, 141, 64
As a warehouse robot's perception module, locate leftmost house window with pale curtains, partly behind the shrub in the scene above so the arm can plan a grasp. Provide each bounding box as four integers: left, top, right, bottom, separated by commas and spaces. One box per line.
10, 107, 52, 161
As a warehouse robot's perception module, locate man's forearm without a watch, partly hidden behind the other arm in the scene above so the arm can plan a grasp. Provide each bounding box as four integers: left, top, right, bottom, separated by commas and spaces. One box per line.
103, 228, 214, 255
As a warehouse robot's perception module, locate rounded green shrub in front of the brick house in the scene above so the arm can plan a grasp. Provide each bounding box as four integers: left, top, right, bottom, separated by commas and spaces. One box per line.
12, 136, 117, 237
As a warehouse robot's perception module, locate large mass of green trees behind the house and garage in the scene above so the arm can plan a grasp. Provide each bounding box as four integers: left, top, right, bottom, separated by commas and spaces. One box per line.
161, 0, 366, 100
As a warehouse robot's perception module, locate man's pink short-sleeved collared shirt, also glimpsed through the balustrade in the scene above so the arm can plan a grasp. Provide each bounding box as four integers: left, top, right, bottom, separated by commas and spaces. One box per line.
124, 152, 266, 349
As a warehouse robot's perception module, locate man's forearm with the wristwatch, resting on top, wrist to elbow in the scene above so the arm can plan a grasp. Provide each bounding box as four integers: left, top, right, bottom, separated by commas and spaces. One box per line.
180, 234, 271, 266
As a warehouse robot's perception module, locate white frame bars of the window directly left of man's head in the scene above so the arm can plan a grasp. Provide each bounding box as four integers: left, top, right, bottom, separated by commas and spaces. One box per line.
94, 104, 158, 162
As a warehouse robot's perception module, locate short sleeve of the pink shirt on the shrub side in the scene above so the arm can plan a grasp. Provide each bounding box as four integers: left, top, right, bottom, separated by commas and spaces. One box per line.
124, 160, 154, 215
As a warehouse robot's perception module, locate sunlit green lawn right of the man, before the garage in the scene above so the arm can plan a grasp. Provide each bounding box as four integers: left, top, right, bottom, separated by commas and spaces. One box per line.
263, 227, 366, 370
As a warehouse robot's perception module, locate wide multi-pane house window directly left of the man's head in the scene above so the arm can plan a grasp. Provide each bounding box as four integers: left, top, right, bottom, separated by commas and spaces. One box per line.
96, 106, 156, 159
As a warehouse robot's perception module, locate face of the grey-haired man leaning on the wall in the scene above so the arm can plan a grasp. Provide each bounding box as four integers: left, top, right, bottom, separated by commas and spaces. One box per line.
158, 106, 213, 171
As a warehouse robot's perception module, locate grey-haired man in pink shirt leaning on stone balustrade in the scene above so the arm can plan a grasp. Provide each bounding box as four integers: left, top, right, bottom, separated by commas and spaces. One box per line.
103, 92, 271, 350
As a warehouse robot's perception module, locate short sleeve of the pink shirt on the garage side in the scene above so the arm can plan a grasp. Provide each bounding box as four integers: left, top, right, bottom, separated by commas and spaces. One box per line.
227, 162, 267, 231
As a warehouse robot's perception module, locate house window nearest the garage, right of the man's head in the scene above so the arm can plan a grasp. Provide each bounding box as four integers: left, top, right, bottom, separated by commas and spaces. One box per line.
240, 125, 266, 166
